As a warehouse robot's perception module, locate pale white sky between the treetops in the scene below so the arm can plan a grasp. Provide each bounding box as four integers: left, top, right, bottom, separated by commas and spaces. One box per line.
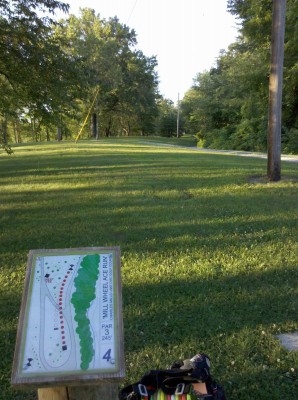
58, 0, 237, 103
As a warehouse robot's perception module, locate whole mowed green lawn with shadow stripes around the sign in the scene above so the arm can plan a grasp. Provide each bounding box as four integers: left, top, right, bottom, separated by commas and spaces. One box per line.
0, 138, 298, 400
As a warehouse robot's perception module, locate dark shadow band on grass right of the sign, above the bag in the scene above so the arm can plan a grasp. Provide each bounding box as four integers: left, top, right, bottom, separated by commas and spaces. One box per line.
123, 267, 298, 350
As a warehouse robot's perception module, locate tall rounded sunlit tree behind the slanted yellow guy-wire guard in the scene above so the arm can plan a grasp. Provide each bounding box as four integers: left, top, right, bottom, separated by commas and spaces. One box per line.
56, 9, 157, 136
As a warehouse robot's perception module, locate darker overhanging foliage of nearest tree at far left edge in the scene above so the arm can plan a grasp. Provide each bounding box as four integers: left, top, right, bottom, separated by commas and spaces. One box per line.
0, 0, 78, 142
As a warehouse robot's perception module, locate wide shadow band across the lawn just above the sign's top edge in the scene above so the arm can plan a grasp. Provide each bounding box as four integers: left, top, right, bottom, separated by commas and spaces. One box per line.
0, 181, 296, 253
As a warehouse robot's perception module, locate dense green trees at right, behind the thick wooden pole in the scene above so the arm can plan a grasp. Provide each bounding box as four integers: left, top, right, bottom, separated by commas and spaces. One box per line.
182, 0, 298, 152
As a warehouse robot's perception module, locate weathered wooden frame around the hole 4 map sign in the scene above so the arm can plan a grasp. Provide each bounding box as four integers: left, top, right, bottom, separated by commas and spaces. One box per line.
11, 246, 125, 389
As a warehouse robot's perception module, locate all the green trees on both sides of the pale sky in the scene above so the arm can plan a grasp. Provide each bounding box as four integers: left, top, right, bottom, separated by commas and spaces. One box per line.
0, 0, 298, 152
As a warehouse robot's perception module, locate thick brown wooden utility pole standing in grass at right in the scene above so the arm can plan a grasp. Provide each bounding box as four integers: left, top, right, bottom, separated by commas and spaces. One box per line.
267, 0, 286, 181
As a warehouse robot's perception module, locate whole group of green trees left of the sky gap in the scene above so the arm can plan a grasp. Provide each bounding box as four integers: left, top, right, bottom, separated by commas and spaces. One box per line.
0, 0, 165, 144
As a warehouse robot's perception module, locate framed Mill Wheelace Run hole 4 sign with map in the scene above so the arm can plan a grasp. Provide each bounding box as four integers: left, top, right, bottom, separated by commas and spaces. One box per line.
12, 248, 124, 387
